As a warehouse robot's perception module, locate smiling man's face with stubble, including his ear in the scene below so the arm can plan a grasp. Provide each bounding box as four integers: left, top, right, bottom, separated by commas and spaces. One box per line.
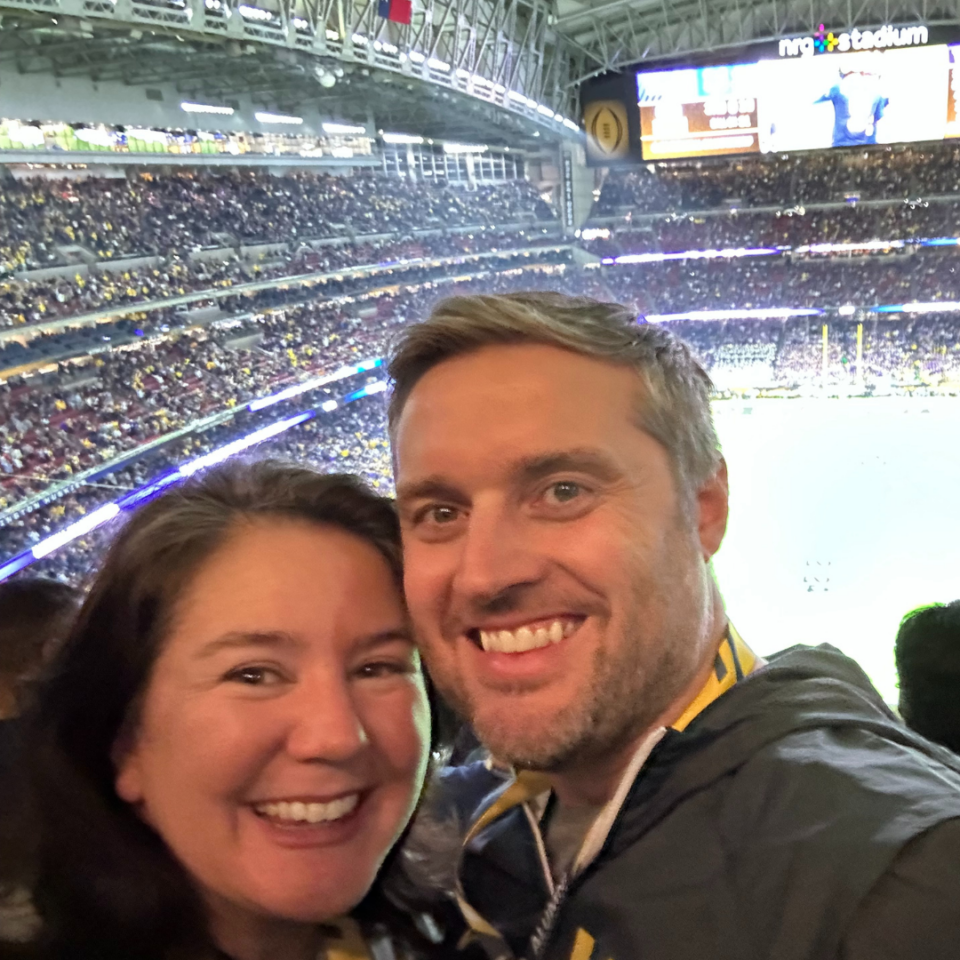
395, 344, 726, 770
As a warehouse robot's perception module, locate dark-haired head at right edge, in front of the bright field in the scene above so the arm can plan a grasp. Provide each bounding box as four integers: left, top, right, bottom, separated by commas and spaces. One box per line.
894, 600, 960, 753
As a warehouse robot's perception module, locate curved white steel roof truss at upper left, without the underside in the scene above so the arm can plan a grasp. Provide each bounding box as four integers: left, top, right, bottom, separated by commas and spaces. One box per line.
0, 0, 582, 138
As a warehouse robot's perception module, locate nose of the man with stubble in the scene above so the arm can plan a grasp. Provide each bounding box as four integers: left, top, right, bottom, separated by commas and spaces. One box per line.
453, 506, 543, 604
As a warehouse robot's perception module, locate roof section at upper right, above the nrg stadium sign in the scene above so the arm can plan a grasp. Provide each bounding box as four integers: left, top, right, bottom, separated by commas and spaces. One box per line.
554, 0, 960, 84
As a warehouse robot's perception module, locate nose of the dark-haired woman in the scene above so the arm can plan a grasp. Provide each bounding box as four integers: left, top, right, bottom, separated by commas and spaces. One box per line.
286, 668, 368, 763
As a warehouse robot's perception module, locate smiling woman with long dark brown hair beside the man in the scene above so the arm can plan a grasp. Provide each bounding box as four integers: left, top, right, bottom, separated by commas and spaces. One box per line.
3, 463, 430, 960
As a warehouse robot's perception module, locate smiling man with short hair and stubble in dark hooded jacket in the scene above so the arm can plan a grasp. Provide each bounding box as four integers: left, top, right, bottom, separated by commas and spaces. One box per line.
390, 294, 960, 960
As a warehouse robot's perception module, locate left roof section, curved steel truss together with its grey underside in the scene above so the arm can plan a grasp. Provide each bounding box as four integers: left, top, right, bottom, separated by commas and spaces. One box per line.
0, 0, 576, 147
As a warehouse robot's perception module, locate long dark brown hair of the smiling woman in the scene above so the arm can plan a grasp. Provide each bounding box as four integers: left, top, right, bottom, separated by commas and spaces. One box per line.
13, 461, 401, 960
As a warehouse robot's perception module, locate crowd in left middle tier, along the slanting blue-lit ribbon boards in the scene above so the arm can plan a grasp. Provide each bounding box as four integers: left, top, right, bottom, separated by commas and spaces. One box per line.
0, 262, 584, 572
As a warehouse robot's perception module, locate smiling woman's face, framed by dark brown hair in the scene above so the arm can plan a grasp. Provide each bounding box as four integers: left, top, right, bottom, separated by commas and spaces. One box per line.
116, 519, 430, 922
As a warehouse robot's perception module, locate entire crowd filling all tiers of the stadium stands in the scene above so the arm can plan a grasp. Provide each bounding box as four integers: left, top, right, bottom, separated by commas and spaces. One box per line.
0, 147, 960, 580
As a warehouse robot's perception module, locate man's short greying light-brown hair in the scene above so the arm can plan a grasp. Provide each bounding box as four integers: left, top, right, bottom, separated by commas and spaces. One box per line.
388, 291, 720, 498
